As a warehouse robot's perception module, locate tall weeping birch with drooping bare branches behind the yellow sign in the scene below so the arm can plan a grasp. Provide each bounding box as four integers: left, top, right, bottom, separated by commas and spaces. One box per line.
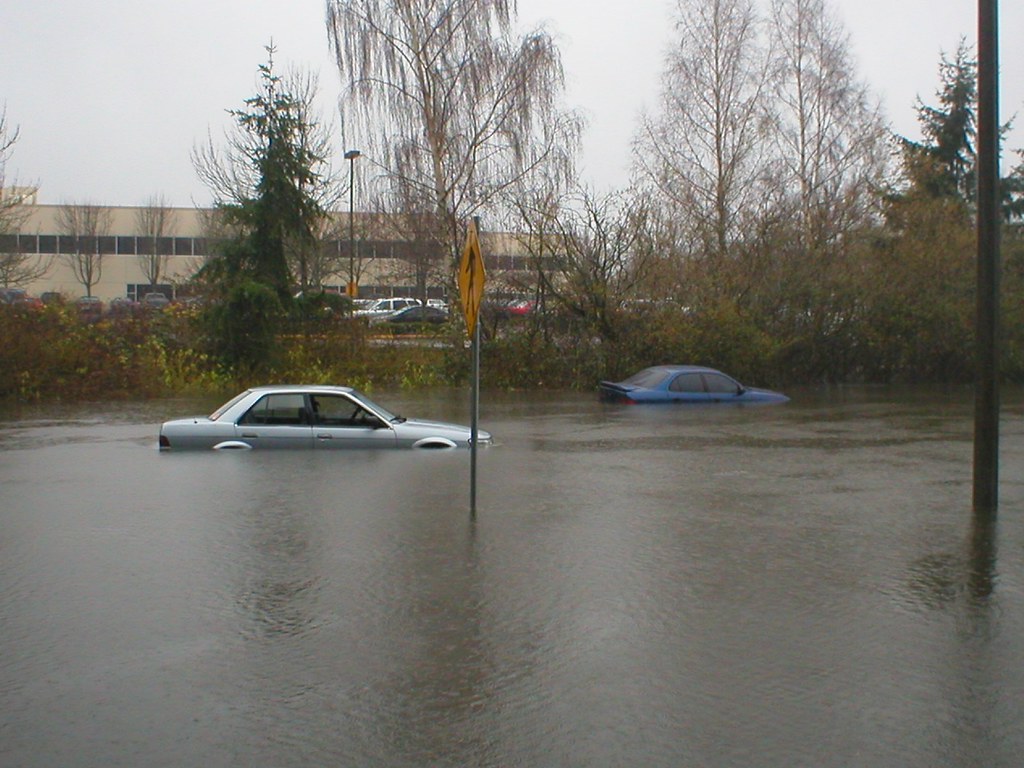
327, 0, 579, 274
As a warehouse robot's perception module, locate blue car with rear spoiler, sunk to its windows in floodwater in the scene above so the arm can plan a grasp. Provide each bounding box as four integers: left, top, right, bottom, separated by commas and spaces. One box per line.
598, 366, 790, 404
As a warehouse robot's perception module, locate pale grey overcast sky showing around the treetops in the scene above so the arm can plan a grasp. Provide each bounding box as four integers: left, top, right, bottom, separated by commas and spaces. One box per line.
0, 0, 1024, 206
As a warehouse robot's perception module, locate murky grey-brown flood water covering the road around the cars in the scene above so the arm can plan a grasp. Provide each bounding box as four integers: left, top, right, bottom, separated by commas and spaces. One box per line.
0, 389, 1024, 768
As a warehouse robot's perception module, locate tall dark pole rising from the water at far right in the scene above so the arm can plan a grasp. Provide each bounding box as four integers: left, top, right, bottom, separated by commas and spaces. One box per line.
974, 0, 999, 515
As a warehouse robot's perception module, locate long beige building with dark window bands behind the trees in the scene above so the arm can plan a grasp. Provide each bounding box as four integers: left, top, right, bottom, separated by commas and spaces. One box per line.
0, 201, 530, 302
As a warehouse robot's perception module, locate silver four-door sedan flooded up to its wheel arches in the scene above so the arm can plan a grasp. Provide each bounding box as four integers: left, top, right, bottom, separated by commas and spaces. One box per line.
160, 385, 490, 451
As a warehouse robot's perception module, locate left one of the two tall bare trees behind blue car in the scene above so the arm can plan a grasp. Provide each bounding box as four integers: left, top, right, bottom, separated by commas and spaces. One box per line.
637, 0, 769, 258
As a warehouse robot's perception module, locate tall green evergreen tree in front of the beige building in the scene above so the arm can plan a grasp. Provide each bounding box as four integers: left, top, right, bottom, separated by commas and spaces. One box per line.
194, 47, 330, 371
